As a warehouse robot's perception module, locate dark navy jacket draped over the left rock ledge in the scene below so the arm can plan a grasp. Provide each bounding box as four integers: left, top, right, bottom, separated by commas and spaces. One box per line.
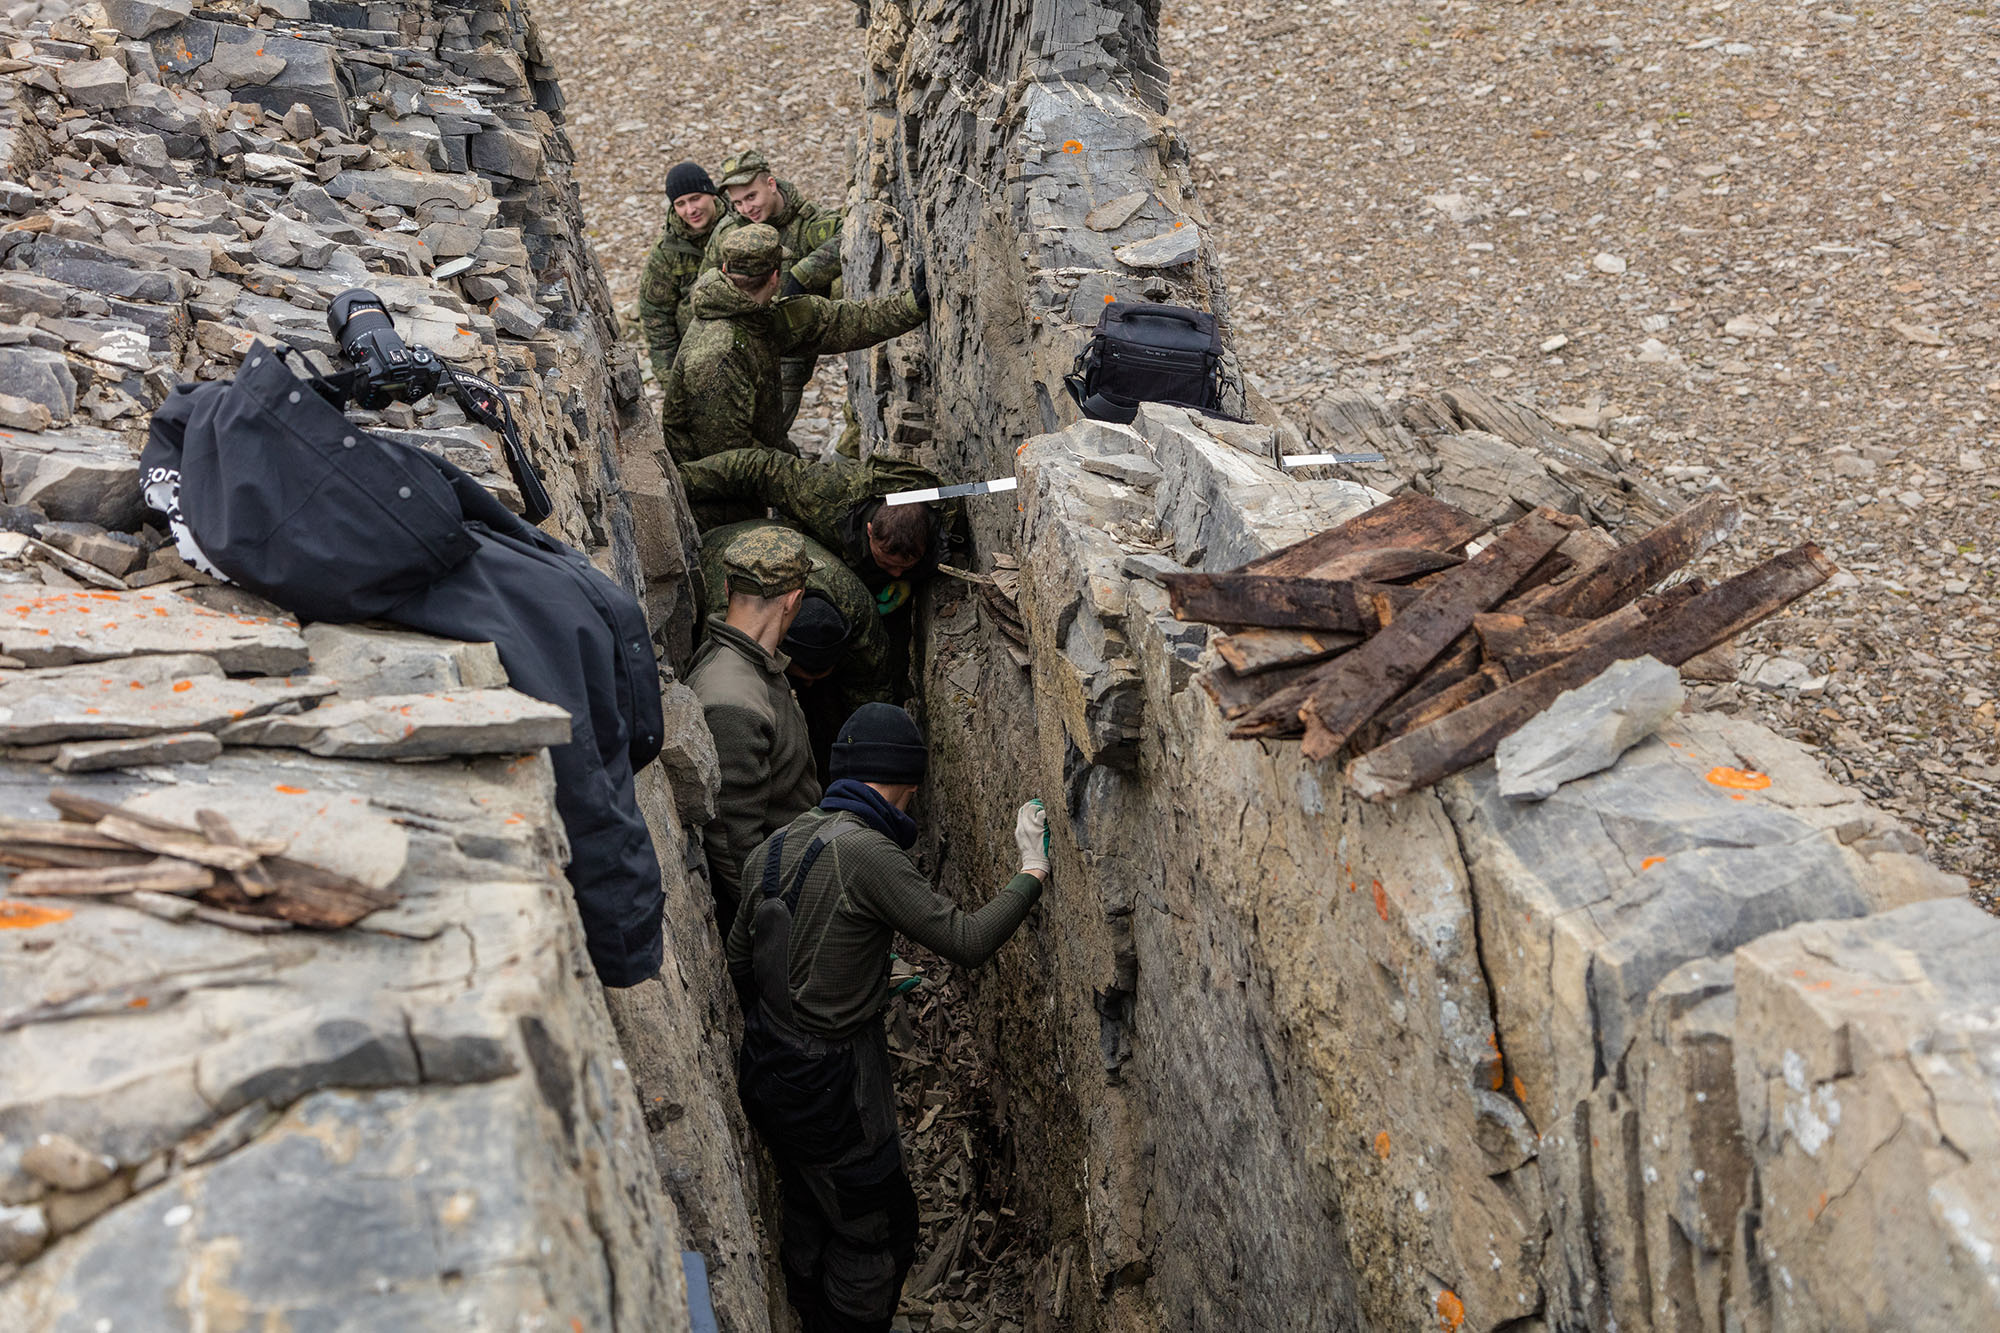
140, 344, 666, 987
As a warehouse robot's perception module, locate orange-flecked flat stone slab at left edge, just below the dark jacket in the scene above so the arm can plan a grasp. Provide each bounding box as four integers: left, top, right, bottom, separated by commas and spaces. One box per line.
0, 652, 334, 748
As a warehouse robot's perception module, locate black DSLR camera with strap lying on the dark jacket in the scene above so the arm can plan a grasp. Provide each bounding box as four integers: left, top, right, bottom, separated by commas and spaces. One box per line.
326, 286, 556, 522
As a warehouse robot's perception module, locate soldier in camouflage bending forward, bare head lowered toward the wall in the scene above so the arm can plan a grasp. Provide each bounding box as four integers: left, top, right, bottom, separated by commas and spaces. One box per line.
680, 448, 946, 592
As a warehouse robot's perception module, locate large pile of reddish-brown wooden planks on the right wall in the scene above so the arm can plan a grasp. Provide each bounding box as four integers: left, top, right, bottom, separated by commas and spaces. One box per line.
1166, 494, 1834, 801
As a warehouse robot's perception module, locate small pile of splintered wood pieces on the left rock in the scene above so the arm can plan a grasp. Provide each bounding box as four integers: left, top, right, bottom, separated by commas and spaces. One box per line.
0, 791, 396, 933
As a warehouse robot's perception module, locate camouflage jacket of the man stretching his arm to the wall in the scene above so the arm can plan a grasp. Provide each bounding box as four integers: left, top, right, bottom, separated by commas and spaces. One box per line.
660, 272, 924, 464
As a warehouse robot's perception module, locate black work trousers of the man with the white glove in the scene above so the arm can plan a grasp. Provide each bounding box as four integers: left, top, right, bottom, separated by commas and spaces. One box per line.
746, 1019, 916, 1333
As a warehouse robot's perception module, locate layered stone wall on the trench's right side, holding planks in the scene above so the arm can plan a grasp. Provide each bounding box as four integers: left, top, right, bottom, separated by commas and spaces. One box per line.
848, 0, 2000, 1329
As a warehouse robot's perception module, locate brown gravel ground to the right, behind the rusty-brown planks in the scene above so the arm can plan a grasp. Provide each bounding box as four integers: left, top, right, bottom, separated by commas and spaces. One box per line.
1162, 0, 2000, 892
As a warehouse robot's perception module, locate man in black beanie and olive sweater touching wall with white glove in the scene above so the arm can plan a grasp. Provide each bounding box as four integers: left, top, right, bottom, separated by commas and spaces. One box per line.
728, 703, 1048, 1333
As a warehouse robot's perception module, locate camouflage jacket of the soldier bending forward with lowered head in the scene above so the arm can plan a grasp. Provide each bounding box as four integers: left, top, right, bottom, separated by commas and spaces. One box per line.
680, 448, 944, 590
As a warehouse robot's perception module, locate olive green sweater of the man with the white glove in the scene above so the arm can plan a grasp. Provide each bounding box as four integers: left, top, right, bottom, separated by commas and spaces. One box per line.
728, 809, 1042, 1039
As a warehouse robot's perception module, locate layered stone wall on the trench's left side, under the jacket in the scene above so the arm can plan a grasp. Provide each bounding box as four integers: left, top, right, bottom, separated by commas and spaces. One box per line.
0, 0, 768, 1329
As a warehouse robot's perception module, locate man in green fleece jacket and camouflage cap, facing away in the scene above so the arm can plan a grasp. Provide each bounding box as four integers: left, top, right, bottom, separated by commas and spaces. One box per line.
688, 524, 820, 939
